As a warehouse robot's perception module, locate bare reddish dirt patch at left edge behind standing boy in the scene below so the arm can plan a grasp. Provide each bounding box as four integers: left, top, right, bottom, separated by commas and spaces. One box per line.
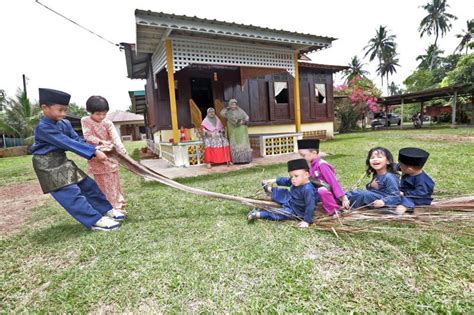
0, 181, 46, 235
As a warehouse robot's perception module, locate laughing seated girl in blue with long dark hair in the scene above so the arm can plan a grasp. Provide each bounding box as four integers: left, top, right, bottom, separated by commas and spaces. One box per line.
346, 147, 400, 209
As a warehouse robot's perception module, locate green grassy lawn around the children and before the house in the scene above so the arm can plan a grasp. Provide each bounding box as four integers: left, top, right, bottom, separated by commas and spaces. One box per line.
0, 128, 474, 313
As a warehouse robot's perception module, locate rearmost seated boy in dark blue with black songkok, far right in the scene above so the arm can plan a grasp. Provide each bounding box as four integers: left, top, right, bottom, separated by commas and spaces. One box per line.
396, 148, 435, 214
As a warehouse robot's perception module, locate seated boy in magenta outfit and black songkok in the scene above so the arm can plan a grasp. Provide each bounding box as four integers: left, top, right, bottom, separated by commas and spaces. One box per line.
298, 139, 349, 215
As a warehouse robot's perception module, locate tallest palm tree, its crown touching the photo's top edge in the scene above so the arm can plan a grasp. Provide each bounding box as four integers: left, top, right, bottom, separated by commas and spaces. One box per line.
418, 0, 457, 45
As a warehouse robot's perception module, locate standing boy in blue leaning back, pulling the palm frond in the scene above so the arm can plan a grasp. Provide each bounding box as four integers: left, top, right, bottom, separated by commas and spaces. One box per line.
31, 89, 125, 231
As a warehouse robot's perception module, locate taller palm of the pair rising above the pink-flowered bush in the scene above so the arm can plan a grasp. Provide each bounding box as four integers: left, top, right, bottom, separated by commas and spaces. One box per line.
364, 25, 397, 86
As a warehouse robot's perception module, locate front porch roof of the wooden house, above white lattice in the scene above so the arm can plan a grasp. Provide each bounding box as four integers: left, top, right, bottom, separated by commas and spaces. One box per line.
135, 9, 336, 53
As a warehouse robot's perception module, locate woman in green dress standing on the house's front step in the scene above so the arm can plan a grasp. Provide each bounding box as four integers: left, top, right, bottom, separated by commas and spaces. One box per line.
221, 99, 252, 163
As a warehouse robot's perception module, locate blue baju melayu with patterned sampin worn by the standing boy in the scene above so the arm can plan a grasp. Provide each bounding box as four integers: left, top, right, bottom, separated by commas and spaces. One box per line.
31, 117, 112, 228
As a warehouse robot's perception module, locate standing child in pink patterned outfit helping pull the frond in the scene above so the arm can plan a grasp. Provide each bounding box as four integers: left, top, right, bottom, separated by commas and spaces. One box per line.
81, 96, 127, 210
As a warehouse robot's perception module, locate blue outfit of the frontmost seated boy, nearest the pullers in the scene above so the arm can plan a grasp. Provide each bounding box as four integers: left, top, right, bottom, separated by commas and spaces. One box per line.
260, 177, 317, 223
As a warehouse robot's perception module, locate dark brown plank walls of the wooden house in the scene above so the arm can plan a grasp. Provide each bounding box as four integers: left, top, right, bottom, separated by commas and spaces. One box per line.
146, 66, 334, 131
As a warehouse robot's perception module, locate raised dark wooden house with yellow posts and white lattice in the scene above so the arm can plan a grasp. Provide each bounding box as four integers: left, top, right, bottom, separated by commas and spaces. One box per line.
121, 10, 346, 166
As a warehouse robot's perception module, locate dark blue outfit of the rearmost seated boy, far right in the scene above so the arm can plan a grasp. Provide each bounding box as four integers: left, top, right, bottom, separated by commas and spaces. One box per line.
400, 171, 435, 209
